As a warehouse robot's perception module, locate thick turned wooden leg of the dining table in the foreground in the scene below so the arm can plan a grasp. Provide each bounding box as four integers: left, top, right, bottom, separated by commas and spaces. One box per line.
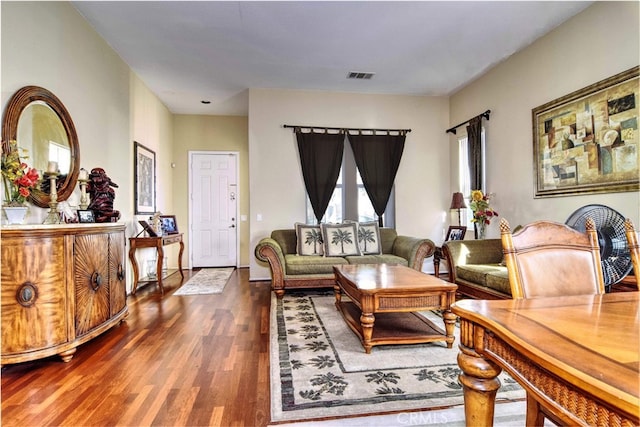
458, 319, 502, 427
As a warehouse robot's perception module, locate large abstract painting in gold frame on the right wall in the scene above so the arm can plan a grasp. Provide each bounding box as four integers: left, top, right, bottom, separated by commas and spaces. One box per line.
532, 67, 640, 198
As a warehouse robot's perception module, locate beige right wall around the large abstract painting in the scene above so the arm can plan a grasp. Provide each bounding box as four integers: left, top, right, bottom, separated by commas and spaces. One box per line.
450, 2, 640, 237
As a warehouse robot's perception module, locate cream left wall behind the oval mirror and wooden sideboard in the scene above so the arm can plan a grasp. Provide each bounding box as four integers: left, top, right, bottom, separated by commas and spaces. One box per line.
0, 2, 177, 289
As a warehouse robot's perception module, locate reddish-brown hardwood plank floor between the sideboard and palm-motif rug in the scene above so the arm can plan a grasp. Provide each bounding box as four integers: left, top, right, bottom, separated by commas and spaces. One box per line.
1, 269, 271, 426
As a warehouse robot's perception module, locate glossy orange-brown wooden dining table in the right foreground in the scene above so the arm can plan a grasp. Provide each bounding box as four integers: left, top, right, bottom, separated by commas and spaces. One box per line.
451, 292, 640, 426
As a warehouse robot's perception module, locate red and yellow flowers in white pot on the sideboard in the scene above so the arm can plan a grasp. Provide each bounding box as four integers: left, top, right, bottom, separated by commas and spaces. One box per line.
2, 141, 40, 224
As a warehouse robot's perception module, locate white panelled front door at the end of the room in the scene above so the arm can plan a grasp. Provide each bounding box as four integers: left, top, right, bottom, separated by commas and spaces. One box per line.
189, 151, 239, 267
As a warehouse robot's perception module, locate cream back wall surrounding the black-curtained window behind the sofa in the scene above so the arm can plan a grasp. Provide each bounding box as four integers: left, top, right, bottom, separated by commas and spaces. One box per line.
249, 89, 451, 280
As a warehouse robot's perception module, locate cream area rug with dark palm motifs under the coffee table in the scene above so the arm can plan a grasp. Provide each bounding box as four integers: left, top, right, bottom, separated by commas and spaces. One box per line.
270, 291, 525, 422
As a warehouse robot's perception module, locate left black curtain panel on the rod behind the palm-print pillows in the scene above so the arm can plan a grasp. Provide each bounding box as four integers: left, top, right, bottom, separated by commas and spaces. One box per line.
295, 129, 344, 224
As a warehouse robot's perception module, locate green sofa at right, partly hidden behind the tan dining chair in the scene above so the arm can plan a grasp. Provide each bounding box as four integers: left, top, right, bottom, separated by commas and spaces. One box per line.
442, 239, 511, 299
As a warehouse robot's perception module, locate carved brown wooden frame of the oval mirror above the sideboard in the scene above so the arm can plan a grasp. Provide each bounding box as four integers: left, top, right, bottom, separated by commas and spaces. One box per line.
2, 86, 80, 208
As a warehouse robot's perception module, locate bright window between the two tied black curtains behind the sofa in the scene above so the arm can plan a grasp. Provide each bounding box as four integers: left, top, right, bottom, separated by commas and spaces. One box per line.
305, 144, 395, 228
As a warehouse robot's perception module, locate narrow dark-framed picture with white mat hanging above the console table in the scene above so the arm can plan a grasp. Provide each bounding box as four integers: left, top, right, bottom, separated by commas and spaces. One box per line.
133, 141, 156, 215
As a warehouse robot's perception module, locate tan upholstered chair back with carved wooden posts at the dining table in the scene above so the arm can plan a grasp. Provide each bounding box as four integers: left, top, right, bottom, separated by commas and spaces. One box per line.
500, 218, 605, 299
